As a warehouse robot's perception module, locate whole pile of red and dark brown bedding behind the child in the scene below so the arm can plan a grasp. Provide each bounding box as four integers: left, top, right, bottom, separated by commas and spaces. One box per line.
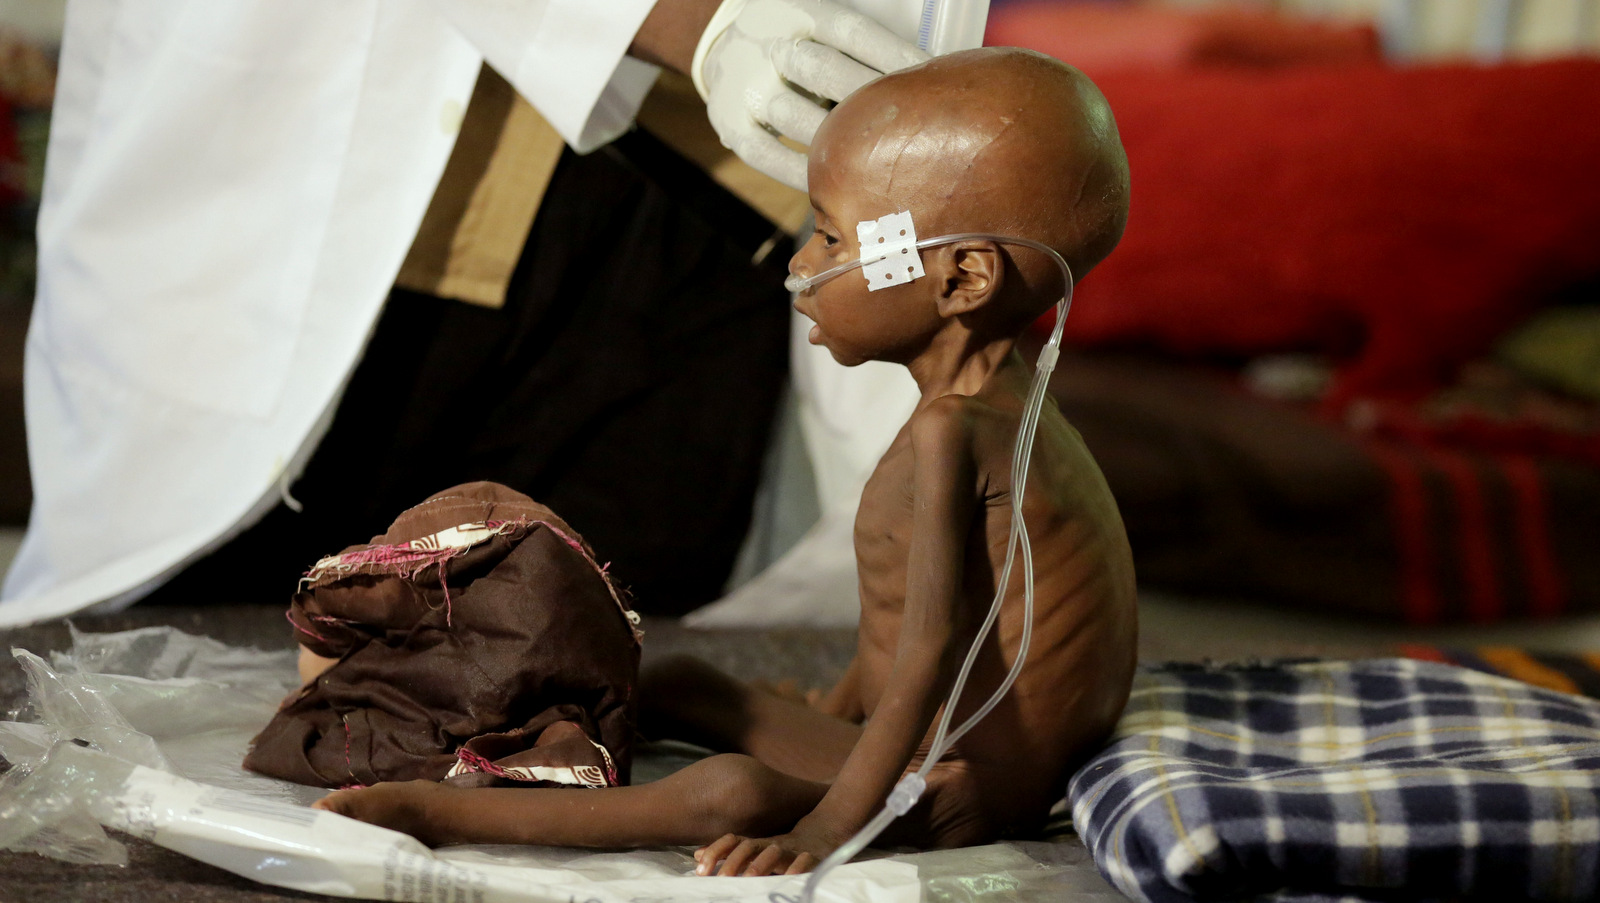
992, 38, 1600, 624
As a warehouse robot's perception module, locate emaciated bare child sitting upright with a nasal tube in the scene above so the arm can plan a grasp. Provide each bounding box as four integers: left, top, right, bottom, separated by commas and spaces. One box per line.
318, 50, 1138, 874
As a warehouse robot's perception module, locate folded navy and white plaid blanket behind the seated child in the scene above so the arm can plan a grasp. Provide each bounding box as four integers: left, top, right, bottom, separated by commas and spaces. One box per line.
1069, 660, 1600, 903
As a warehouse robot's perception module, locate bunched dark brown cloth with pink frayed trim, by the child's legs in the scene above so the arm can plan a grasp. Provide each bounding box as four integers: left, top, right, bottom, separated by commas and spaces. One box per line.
245, 484, 640, 788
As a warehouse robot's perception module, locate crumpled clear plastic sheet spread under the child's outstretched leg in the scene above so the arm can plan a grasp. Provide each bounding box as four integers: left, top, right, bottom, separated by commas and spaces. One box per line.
0, 628, 1122, 903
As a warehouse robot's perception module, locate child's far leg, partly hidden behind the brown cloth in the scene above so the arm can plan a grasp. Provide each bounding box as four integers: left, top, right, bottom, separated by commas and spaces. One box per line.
638, 656, 861, 783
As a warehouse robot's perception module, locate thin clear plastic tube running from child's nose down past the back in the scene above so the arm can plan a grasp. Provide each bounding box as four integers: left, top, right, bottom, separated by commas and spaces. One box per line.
784, 232, 1072, 903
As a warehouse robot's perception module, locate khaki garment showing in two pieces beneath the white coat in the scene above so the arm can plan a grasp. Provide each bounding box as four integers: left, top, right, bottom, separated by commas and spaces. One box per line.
395, 66, 808, 307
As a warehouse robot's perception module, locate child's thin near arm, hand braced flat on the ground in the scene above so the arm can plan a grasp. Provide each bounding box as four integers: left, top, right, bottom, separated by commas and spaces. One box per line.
698, 395, 978, 874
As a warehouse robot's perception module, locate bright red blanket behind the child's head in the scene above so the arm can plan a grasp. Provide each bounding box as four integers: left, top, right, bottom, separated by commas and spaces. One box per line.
1067, 61, 1600, 400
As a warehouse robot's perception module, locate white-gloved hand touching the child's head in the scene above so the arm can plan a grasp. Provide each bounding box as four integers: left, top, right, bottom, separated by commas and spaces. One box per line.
690, 0, 928, 191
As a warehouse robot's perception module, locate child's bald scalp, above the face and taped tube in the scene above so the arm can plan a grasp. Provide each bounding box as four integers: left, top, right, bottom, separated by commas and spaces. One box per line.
810, 48, 1128, 318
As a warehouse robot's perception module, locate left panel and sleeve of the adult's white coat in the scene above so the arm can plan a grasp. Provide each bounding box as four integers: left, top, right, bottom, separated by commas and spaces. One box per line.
0, 0, 656, 626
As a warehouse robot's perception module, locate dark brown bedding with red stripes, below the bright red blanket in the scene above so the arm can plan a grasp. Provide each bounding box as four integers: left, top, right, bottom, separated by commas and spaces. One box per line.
1051, 352, 1600, 624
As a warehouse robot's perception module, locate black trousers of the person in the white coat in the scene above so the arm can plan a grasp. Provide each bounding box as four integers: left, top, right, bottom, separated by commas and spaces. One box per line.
149, 131, 789, 613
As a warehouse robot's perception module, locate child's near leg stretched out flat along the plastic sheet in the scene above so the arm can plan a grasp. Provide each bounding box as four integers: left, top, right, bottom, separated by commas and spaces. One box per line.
315, 756, 827, 847
